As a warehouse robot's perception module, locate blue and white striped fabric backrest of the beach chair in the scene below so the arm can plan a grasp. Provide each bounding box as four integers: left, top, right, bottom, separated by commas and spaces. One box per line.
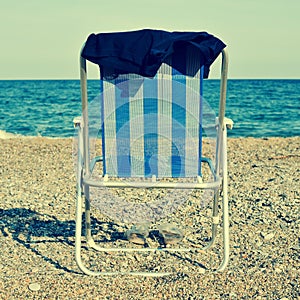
101, 50, 203, 178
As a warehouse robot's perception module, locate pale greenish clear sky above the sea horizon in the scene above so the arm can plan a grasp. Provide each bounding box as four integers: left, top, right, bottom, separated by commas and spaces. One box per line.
0, 0, 300, 80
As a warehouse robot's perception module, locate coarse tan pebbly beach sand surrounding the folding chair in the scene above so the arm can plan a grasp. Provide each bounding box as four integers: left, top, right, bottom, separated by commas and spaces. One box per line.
0, 137, 300, 300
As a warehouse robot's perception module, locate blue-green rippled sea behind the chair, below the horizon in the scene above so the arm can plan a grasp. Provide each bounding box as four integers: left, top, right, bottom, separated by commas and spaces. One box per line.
0, 79, 300, 138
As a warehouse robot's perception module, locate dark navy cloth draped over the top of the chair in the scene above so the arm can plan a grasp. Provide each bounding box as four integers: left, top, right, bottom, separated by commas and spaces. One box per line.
81, 29, 226, 78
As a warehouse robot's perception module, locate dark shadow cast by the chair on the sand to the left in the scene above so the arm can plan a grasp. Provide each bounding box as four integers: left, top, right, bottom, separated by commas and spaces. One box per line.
0, 208, 124, 274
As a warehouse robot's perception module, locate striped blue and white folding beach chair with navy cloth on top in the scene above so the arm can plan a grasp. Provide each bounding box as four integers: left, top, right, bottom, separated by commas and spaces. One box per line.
74, 30, 233, 276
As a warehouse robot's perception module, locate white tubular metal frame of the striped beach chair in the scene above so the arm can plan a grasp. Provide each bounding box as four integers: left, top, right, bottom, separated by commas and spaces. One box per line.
74, 49, 233, 276
